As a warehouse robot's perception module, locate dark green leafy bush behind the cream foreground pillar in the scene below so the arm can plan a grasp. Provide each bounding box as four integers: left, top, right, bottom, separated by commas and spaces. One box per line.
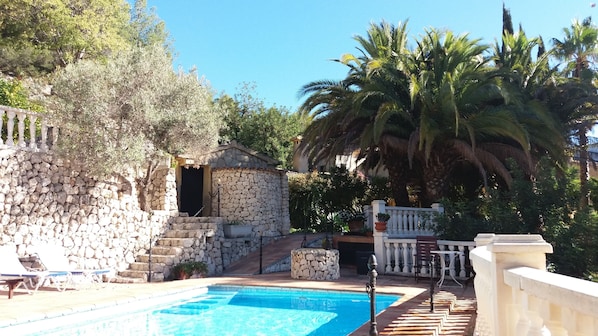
436, 159, 598, 279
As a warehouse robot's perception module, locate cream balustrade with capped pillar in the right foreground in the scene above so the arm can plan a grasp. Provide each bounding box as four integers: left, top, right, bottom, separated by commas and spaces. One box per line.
470, 234, 598, 336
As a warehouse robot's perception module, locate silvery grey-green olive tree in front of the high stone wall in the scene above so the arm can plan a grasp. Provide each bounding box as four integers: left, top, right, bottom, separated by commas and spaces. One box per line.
49, 46, 222, 210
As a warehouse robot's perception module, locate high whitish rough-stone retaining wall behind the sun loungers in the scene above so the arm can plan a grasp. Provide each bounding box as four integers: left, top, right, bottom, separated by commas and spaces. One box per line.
0, 149, 170, 271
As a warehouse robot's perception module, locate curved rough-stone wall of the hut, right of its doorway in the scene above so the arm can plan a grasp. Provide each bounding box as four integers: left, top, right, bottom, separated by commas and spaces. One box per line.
212, 168, 290, 236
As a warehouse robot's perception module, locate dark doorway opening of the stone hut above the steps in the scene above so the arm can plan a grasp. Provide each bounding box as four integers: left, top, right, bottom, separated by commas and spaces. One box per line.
180, 167, 203, 216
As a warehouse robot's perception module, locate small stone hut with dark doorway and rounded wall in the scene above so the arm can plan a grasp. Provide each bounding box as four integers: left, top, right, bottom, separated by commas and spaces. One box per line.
177, 141, 290, 237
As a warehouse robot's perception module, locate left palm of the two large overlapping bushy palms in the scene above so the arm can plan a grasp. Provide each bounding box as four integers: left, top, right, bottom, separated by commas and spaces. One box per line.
300, 22, 418, 205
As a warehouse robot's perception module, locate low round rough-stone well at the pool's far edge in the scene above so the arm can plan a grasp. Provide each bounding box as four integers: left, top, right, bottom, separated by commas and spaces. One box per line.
291, 248, 340, 280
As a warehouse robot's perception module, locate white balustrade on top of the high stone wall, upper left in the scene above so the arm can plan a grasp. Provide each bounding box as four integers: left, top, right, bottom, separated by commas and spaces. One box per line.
0, 105, 58, 151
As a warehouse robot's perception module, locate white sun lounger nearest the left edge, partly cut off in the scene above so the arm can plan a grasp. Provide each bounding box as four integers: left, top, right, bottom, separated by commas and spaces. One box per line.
0, 246, 71, 293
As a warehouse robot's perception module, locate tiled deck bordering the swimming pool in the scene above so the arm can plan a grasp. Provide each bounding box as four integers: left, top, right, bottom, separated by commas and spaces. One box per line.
0, 268, 475, 335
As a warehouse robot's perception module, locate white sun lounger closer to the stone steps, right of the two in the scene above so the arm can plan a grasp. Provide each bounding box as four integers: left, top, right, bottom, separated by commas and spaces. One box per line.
35, 245, 114, 285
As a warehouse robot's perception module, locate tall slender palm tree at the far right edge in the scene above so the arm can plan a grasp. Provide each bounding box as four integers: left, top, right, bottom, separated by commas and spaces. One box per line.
552, 18, 598, 207
